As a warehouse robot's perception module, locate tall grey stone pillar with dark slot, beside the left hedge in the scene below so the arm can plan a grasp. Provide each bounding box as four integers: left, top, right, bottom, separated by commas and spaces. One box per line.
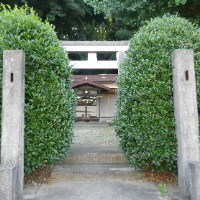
0, 50, 25, 200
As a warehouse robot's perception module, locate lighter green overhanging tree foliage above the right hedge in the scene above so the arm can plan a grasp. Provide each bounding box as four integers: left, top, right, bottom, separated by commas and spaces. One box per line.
85, 0, 200, 27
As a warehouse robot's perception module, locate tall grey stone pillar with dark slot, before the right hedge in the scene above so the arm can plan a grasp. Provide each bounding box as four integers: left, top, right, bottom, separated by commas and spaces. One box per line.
173, 49, 199, 197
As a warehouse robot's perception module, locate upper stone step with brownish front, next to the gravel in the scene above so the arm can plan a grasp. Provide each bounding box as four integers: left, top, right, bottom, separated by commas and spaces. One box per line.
58, 146, 128, 165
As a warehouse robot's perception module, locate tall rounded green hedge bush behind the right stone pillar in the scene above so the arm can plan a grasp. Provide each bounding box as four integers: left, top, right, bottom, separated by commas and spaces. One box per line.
115, 15, 200, 172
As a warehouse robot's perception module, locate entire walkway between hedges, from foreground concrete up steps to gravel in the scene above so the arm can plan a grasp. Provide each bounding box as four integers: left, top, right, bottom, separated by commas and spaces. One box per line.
24, 126, 182, 200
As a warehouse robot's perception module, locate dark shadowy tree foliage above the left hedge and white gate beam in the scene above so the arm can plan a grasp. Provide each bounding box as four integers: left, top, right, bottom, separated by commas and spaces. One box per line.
2, 0, 116, 40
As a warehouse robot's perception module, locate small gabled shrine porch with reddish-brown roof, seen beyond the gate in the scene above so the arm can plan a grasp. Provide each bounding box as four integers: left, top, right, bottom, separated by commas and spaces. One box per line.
72, 77, 115, 122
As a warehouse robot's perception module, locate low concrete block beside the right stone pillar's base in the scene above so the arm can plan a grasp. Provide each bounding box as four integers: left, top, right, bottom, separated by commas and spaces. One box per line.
189, 161, 200, 200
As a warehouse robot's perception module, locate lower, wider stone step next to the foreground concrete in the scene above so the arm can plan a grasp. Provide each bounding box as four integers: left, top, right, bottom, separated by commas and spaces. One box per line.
51, 163, 145, 180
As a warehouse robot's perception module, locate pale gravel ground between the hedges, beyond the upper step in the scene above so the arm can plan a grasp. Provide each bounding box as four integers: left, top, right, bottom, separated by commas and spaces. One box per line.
73, 126, 118, 145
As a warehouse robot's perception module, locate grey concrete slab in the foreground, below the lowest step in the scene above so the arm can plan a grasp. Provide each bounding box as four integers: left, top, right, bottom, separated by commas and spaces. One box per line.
24, 180, 172, 200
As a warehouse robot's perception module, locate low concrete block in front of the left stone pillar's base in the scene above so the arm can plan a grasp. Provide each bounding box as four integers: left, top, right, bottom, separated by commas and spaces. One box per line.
0, 165, 19, 200
